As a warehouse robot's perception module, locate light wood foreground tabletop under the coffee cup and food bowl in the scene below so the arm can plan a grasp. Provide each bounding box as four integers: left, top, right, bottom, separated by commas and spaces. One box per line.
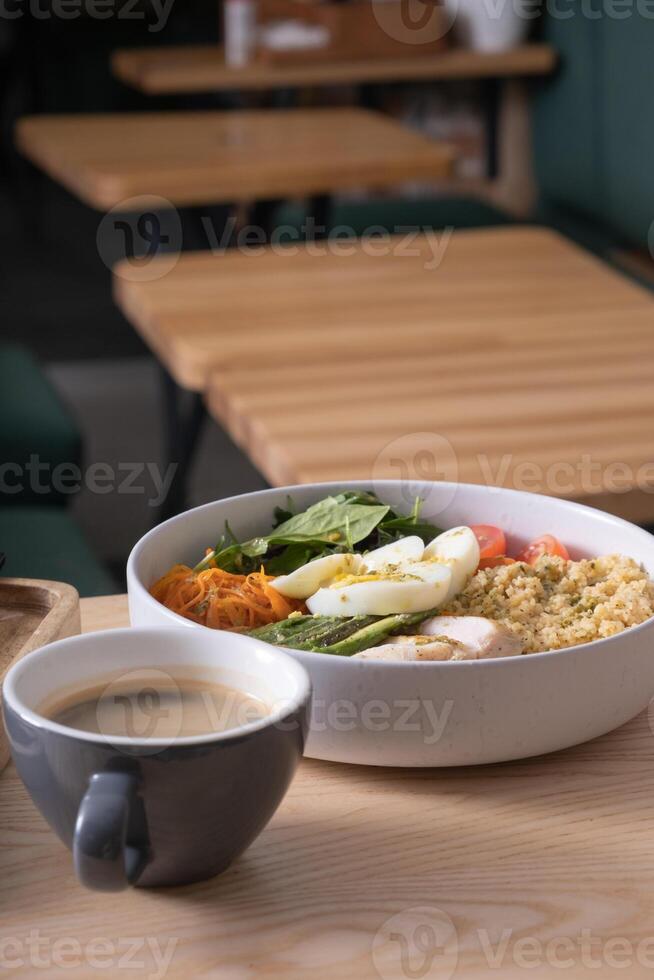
0, 596, 654, 980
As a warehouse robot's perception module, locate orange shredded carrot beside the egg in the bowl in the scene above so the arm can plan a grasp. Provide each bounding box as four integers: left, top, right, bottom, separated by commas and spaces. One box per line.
150, 565, 306, 632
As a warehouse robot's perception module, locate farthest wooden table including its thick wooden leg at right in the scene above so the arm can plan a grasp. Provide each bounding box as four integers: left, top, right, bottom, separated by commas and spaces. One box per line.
111, 44, 558, 203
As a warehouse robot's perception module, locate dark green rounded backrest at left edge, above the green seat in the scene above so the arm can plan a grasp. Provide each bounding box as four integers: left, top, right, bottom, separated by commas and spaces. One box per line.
0, 345, 81, 506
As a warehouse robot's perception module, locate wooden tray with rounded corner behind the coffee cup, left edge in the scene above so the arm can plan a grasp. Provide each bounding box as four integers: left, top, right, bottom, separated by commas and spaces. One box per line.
0, 578, 81, 771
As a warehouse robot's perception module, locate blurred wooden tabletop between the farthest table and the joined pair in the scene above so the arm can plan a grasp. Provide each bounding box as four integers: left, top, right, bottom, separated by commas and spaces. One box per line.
16, 109, 454, 210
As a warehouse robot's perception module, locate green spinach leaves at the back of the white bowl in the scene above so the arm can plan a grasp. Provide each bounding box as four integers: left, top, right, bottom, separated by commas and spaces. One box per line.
194, 490, 440, 575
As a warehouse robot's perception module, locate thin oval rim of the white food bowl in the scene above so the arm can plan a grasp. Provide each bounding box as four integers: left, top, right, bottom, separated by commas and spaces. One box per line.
126, 480, 654, 670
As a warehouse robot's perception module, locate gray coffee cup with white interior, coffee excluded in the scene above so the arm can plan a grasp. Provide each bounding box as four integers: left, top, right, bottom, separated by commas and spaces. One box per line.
3, 628, 311, 891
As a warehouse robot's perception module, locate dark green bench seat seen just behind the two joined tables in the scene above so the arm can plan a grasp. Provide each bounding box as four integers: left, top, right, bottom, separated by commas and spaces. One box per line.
275, 197, 511, 236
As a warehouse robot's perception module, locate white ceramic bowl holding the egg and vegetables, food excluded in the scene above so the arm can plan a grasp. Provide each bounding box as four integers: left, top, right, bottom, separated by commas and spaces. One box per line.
127, 480, 654, 766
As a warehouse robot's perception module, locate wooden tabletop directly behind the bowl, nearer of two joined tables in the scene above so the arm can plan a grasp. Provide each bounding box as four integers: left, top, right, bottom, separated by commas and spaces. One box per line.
208, 310, 654, 522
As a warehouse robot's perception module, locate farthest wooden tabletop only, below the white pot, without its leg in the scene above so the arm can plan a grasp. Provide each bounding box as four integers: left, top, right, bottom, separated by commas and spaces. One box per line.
111, 44, 557, 95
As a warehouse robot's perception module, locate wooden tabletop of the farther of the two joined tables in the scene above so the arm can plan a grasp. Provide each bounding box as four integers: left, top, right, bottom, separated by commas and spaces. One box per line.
114, 227, 653, 390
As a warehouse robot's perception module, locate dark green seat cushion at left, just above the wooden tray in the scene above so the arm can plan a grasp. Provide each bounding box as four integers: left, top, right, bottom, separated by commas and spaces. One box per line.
0, 505, 116, 596
